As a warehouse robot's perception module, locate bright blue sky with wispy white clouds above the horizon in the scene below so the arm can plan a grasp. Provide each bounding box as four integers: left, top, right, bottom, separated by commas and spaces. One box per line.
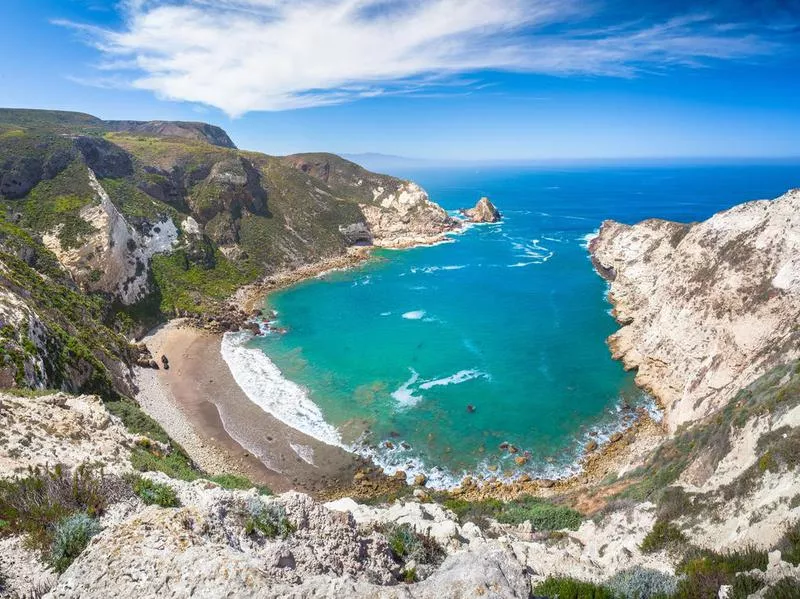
0, 0, 800, 160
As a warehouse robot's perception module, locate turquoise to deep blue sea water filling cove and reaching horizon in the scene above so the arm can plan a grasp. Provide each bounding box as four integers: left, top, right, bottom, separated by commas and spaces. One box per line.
242, 165, 800, 484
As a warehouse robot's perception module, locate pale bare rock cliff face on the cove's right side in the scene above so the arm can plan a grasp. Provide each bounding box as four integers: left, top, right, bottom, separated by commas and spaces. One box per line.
590, 190, 800, 431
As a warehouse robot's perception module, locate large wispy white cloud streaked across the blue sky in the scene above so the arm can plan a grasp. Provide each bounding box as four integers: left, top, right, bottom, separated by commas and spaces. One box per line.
57, 0, 788, 116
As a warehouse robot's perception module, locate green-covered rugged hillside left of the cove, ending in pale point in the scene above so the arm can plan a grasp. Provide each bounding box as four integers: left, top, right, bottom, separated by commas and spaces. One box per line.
0, 109, 457, 393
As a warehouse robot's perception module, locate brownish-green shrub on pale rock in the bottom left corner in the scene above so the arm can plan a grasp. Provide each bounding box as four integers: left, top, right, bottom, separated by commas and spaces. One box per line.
0, 466, 120, 551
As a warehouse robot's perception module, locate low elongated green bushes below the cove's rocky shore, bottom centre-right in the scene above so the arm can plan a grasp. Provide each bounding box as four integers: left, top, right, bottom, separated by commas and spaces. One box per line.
442, 496, 583, 531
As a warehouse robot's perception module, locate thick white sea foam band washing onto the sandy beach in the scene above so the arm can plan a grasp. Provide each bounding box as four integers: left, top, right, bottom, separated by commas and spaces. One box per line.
221, 333, 343, 448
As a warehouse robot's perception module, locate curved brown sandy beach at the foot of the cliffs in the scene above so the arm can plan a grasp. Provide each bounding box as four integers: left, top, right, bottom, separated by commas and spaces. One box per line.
137, 320, 364, 495
